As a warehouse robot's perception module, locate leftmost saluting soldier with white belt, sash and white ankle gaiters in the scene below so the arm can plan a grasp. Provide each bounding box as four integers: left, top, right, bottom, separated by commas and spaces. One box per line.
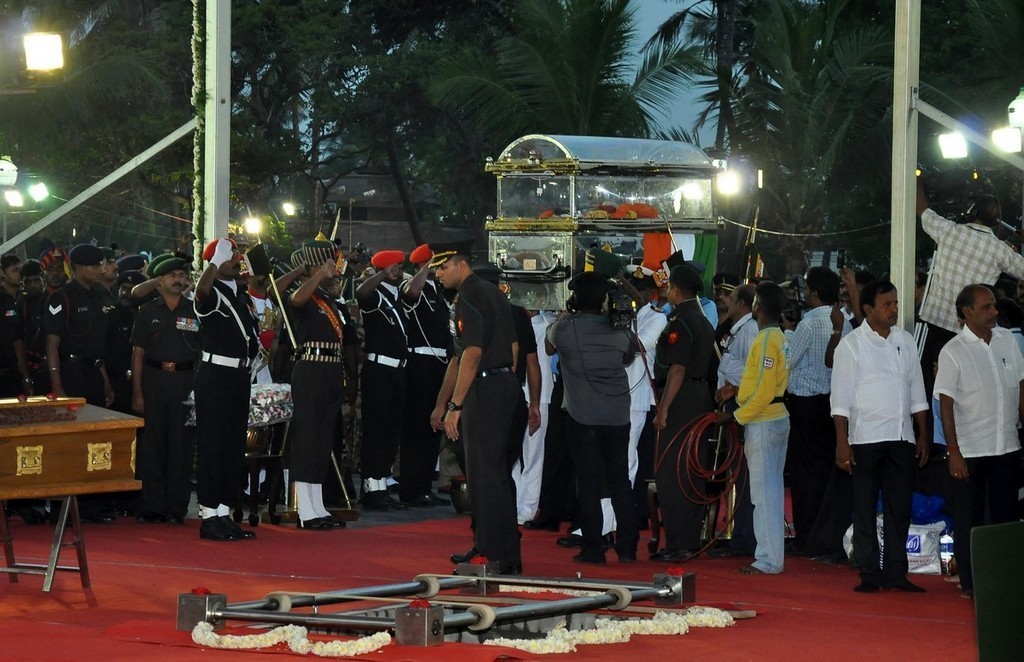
195, 239, 258, 540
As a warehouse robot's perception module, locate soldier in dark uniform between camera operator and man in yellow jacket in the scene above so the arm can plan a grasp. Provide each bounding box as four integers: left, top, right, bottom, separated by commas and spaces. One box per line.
651, 264, 715, 562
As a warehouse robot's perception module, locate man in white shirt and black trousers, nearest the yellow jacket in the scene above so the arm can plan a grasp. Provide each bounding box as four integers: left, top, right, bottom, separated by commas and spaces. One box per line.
831, 281, 929, 593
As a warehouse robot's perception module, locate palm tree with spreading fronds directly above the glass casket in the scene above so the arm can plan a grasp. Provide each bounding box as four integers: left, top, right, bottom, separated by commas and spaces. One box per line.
432, 0, 703, 147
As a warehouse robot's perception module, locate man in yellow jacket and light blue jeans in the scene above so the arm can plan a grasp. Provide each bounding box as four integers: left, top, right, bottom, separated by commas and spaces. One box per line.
718, 283, 790, 575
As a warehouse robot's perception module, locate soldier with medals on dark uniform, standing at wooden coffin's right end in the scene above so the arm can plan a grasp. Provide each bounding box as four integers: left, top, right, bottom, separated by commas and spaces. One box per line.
130, 253, 199, 524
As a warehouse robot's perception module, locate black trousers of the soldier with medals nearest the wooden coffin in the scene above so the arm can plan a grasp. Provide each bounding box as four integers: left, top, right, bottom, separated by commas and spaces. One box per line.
135, 368, 194, 518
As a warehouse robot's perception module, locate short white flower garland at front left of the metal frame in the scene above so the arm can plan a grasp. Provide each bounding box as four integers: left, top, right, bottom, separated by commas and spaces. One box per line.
193, 621, 391, 658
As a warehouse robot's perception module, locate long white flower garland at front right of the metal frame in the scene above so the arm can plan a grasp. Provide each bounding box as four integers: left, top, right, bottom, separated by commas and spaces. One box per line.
483, 607, 735, 655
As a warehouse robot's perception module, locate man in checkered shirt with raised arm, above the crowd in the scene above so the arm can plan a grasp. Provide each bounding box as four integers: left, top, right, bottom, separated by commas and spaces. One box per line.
918, 178, 1024, 399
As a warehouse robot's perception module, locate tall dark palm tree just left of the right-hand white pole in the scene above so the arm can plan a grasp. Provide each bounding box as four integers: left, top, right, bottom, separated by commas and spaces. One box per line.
736, 0, 892, 273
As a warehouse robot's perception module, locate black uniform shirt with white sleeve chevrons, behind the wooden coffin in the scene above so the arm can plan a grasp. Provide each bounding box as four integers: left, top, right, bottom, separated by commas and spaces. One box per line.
43, 281, 114, 361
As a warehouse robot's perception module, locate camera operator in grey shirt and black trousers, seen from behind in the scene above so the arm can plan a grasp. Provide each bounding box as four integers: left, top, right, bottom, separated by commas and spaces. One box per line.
545, 272, 639, 564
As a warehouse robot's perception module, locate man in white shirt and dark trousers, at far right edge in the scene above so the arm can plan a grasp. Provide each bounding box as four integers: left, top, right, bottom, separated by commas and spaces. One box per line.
935, 285, 1024, 597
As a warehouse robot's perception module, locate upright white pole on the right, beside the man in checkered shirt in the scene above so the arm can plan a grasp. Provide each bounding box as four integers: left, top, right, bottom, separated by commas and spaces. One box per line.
889, 0, 921, 331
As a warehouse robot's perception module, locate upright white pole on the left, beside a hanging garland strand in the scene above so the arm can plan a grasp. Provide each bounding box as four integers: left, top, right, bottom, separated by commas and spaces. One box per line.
202, 0, 231, 244
